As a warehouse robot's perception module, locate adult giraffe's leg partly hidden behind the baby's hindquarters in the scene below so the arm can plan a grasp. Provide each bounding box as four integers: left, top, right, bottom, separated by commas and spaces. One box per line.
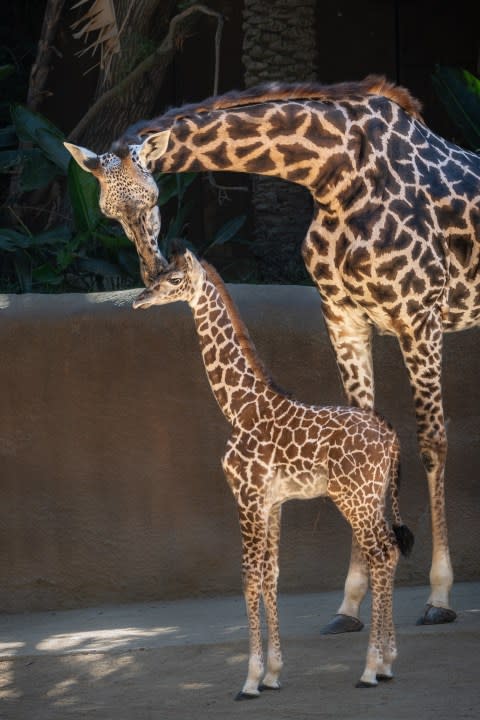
314, 302, 374, 635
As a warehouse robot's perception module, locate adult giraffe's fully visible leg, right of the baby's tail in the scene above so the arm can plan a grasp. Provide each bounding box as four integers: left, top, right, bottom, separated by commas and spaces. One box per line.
399, 313, 456, 625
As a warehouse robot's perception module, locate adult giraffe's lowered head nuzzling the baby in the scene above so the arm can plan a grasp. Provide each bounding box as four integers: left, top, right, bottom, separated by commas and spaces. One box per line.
64, 130, 170, 287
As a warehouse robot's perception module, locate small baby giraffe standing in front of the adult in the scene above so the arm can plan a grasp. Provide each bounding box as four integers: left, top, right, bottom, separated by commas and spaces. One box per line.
133, 250, 413, 700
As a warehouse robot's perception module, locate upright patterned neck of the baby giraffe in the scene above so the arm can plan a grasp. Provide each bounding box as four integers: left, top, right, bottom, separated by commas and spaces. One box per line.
190, 263, 274, 425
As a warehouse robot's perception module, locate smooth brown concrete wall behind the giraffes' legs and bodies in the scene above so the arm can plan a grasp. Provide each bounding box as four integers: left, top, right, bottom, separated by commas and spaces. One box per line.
0, 285, 480, 611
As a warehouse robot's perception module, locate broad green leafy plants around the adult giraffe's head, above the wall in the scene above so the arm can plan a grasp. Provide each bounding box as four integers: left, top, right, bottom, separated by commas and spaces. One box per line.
0, 104, 182, 292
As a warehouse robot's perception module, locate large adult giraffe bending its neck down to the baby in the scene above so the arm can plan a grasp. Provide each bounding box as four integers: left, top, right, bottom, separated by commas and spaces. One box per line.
66, 76, 480, 632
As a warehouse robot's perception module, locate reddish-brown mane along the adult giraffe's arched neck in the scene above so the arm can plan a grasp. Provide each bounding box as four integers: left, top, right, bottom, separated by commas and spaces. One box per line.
119, 75, 423, 147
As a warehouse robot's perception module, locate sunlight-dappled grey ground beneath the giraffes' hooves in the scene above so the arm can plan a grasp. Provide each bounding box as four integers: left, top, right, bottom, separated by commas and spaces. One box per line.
0, 583, 480, 720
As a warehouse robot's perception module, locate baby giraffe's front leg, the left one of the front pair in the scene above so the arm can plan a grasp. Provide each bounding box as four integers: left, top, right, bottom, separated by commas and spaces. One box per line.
235, 507, 267, 700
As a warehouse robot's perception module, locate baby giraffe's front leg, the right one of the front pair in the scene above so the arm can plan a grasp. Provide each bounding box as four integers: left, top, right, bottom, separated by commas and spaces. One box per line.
260, 505, 283, 690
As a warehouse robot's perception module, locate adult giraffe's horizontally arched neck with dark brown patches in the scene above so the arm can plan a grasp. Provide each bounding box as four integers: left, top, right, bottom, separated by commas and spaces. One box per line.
156, 101, 347, 192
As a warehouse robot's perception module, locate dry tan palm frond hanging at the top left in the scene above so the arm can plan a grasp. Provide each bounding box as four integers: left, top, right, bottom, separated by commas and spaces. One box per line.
71, 0, 123, 77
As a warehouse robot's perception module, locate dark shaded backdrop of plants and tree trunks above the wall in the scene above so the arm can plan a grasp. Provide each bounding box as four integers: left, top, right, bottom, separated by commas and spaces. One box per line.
0, 0, 480, 292
